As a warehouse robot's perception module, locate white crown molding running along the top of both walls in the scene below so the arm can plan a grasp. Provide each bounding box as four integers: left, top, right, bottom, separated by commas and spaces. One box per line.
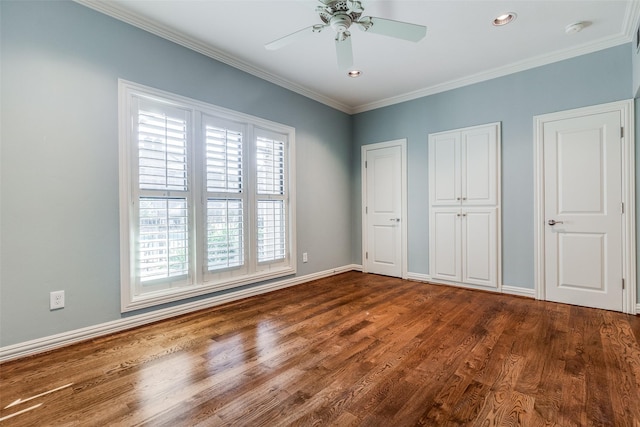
74, 0, 640, 114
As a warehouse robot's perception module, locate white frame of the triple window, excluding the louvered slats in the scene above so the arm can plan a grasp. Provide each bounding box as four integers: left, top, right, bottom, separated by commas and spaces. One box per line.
118, 79, 297, 312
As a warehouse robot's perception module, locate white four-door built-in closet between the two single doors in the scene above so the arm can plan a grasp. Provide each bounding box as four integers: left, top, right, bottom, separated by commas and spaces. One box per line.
429, 123, 500, 289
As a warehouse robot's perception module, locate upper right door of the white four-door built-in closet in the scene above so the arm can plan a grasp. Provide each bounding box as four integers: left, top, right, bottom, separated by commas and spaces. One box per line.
461, 125, 498, 206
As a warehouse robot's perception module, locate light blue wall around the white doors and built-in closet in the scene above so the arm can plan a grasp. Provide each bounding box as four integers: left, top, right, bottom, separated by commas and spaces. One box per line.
351, 44, 632, 288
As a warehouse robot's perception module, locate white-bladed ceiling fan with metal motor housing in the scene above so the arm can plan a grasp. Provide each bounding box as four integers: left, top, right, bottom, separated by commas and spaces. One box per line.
264, 0, 427, 69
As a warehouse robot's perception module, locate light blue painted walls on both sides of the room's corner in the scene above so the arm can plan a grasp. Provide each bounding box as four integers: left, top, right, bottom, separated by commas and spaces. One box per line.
0, 1, 640, 352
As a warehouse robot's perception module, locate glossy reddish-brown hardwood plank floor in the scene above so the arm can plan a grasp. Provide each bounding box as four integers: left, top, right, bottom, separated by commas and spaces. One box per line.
0, 272, 640, 426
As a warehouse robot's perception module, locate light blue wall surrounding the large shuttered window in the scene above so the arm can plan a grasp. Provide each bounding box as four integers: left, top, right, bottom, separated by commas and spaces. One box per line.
0, 1, 351, 346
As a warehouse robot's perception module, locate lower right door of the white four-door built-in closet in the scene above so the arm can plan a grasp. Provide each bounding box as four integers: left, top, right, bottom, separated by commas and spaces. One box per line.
461, 207, 498, 288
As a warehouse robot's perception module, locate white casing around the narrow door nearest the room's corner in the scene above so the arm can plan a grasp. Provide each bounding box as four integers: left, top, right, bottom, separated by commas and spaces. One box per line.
360, 138, 409, 279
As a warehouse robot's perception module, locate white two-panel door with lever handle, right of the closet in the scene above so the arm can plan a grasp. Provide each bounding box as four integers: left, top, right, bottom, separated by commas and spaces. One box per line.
543, 111, 623, 311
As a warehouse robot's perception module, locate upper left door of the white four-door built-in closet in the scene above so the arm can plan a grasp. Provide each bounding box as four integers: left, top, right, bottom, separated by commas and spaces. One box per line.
429, 132, 461, 206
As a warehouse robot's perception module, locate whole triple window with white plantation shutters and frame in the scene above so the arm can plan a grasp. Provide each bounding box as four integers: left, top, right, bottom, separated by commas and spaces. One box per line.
119, 80, 296, 311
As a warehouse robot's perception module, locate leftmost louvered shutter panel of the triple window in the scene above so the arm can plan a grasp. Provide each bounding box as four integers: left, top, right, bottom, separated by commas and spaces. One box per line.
136, 100, 190, 282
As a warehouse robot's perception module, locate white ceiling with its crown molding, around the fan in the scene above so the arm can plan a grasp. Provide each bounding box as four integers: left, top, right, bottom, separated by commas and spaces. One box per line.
76, 0, 640, 113
